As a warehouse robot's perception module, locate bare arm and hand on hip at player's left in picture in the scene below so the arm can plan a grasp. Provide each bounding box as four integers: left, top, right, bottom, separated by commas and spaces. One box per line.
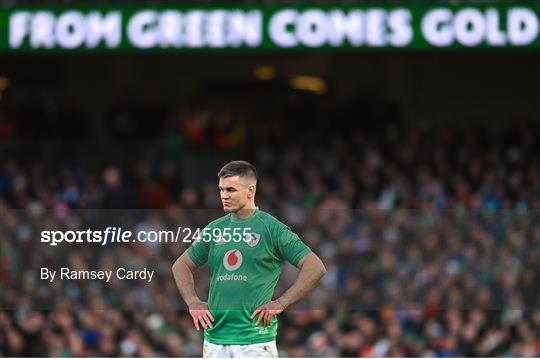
172, 251, 214, 330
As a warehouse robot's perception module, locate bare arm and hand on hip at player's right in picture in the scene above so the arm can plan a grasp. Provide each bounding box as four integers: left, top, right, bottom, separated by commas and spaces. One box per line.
251, 252, 326, 326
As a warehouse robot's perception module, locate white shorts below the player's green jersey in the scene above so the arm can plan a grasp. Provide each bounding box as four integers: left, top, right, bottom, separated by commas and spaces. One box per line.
203, 340, 278, 358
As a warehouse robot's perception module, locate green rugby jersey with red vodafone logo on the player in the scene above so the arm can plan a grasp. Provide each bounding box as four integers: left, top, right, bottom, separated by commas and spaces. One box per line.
188, 208, 310, 345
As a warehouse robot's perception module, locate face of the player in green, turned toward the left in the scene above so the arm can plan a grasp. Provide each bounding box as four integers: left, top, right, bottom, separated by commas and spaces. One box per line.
219, 176, 255, 212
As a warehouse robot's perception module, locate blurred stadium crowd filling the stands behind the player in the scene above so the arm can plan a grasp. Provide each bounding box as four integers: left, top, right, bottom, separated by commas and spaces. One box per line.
0, 102, 540, 357
